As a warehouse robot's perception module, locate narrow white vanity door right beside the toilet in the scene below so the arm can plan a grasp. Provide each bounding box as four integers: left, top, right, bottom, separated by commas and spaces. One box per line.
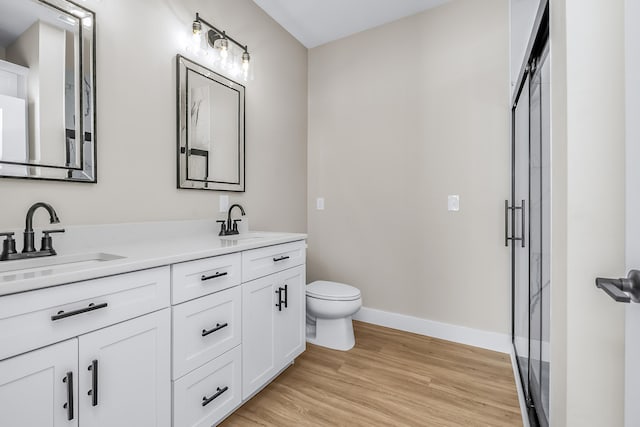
274, 265, 306, 370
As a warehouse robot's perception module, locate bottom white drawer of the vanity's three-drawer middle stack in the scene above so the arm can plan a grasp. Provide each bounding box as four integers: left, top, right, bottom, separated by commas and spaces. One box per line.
173, 346, 242, 427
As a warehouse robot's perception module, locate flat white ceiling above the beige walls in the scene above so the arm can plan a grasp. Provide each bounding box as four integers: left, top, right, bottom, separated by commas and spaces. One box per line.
253, 0, 448, 48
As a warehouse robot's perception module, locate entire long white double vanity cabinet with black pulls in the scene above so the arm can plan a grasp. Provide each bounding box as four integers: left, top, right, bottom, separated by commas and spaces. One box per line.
0, 235, 306, 427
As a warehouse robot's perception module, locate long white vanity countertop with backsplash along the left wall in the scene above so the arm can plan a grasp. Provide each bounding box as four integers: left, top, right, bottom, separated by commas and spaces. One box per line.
0, 221, 307, 295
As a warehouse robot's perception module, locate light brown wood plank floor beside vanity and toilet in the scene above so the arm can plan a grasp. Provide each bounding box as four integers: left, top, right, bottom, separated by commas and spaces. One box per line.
222, 322, 522, 427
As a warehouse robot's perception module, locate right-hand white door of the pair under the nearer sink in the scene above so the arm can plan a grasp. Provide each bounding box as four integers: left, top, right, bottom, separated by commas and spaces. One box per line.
79, 309, 171, 427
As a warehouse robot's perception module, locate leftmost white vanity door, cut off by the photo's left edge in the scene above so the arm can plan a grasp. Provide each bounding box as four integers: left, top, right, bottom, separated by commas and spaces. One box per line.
0, 338, 78, 427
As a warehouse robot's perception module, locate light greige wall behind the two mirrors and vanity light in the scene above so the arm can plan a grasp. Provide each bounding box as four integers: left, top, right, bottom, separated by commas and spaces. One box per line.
0, 0, 307, 231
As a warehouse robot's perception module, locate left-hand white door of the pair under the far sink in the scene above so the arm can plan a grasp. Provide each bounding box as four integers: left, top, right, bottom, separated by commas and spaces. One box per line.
242, 274, 277, 399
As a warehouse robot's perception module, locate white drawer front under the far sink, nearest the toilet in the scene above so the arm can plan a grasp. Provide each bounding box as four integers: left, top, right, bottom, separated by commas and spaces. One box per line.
242, 240, 307, 282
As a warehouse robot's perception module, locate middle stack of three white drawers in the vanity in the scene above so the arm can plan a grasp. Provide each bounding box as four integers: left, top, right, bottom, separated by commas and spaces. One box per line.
171, 252, 242, 427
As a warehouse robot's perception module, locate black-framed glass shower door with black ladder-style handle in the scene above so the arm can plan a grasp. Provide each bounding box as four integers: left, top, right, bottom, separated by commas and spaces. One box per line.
505, 26, 551, 426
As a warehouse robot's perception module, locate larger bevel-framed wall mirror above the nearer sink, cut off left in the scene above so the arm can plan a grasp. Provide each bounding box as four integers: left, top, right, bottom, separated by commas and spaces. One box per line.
0, 0, 96, 182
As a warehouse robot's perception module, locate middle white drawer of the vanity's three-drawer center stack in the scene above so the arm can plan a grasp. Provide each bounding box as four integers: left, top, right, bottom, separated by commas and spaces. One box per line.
173, 286, 242, 378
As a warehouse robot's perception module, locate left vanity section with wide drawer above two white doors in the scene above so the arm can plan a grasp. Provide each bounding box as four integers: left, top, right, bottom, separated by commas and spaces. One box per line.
0, 267, 171, 427
